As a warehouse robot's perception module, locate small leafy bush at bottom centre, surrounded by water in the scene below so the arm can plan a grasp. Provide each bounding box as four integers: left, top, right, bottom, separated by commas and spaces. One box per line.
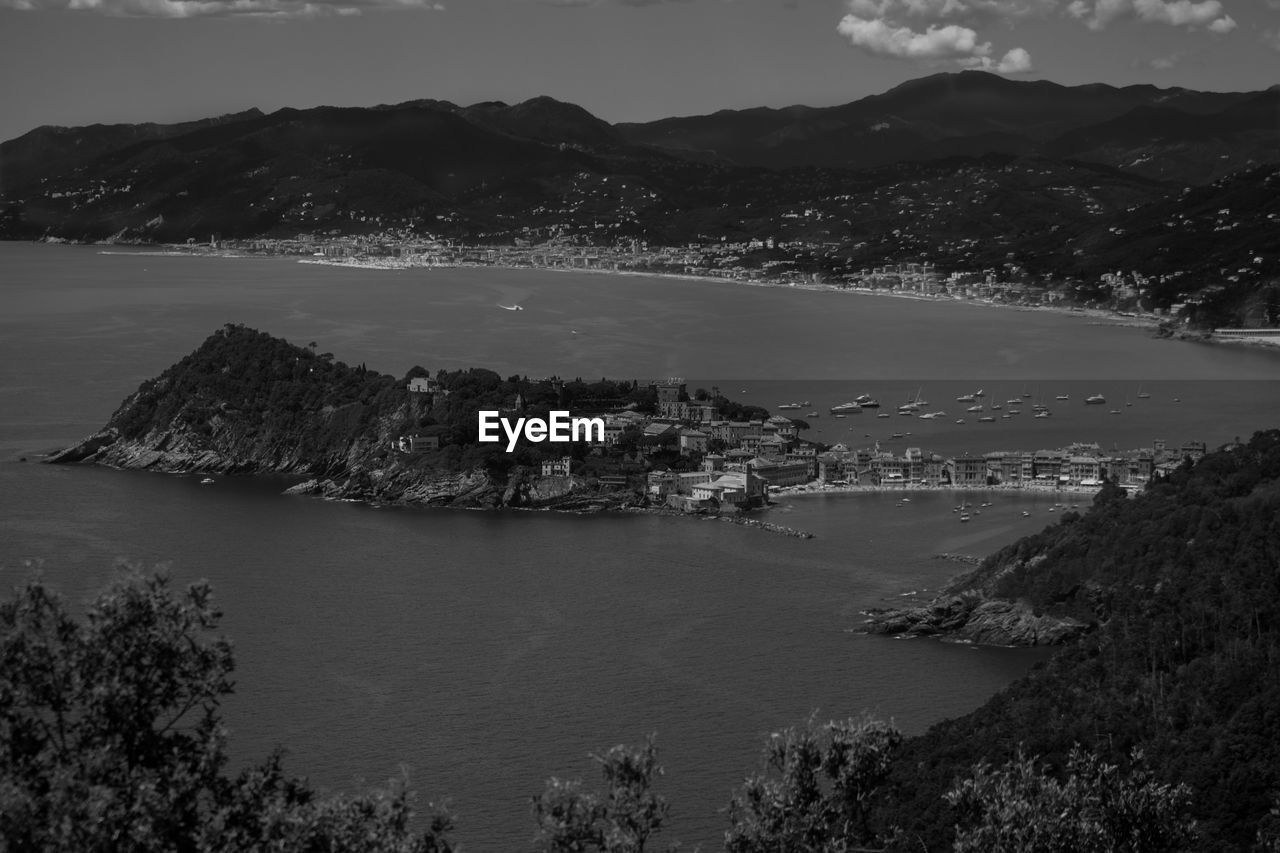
532, 735, 669, 853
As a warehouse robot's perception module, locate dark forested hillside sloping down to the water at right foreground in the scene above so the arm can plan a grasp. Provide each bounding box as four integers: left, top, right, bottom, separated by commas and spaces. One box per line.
881, 430, 1280, 850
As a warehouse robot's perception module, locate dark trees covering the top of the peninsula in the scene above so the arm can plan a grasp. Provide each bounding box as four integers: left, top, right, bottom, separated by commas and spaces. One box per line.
109, 325, 727, 473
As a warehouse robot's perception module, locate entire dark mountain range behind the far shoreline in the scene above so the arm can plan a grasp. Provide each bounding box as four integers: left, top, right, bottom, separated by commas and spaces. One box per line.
0, 70, 1280, 322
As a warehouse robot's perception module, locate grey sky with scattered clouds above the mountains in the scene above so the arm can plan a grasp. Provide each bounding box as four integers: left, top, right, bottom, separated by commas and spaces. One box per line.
0, 0, 1280, 140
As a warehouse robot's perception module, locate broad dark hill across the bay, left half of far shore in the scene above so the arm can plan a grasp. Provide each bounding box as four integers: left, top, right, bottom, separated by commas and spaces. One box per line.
6, 106, 637, 242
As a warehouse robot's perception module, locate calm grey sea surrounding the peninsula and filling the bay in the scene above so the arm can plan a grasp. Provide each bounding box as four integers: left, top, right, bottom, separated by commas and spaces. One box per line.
0, 243, 1280, 853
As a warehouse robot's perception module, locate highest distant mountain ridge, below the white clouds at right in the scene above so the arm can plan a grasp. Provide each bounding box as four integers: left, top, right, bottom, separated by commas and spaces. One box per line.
618, 70, 1264, 177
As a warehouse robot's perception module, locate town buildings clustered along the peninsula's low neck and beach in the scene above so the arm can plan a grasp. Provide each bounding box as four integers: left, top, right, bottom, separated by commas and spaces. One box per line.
394, 378, 1206, 520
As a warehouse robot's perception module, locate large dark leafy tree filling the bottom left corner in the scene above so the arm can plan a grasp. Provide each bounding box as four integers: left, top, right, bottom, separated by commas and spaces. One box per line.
0, 573, 451, 853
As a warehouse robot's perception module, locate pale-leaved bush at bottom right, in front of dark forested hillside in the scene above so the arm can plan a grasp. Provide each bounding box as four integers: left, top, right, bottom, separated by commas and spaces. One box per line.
945, 747, 1196, 853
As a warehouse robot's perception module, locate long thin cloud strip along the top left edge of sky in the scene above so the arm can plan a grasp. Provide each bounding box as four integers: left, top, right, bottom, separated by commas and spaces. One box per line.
0, 0, 444, 19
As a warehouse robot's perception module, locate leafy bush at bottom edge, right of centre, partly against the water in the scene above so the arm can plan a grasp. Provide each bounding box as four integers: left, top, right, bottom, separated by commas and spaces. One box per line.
724, 716, 902, 853
